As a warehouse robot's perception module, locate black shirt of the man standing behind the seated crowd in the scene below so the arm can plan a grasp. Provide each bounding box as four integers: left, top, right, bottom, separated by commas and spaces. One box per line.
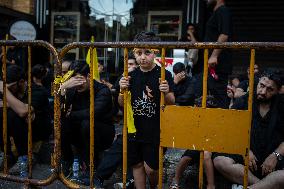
204, 5, 232, 77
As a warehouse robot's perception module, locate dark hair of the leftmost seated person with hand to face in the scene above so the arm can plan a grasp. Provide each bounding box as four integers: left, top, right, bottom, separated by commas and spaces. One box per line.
6, 65, 25, 84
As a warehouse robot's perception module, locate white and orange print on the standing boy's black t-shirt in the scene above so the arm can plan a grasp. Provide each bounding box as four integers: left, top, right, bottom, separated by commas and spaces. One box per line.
132, 86, 157, 117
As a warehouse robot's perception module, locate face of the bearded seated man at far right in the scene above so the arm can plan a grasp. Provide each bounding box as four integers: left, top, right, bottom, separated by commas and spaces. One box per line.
256, 77, 278, 103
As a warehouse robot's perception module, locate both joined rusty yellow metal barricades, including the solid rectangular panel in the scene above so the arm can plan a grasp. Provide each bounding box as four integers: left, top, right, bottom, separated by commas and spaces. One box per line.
0, 41, 284, 188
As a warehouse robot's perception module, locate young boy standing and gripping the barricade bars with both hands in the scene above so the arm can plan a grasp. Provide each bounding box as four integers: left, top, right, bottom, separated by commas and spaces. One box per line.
118, 32, 175, 189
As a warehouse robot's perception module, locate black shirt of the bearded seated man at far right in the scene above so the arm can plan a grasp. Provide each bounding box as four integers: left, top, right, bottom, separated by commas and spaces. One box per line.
232, 95, 284, 163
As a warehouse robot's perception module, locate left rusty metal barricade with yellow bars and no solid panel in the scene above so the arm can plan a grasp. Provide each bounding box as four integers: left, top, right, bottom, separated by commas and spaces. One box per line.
0, 40, 60, 186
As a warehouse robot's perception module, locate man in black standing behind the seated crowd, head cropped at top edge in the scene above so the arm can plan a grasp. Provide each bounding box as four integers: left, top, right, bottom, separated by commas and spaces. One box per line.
197, 0, 232, 108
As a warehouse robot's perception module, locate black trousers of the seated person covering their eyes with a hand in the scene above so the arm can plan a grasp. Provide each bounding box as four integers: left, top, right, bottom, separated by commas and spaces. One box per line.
61, 119, 115, 165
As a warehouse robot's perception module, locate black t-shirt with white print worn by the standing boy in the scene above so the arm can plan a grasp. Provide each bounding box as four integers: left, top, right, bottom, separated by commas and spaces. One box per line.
129, 66, 173, 143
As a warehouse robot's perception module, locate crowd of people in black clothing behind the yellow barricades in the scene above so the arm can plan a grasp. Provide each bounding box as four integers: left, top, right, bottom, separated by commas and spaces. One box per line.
0, 0, 284, 189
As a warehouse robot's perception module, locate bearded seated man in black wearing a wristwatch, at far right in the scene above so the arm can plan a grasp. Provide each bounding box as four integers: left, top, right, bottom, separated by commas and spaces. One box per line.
214, 72, 284, 189
